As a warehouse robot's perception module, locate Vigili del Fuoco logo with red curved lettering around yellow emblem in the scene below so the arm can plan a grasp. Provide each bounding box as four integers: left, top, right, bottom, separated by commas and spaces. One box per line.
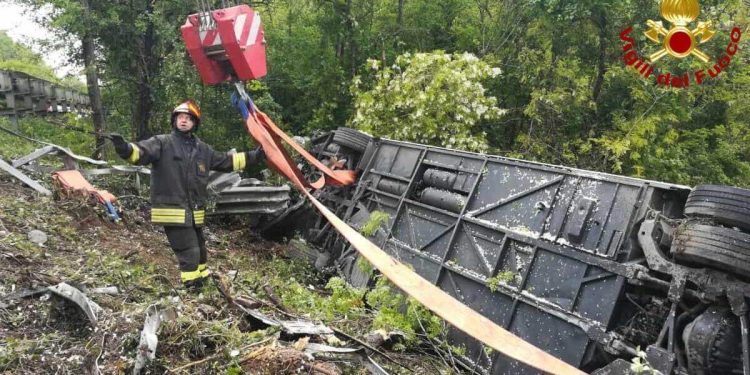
620, 0, 742, 88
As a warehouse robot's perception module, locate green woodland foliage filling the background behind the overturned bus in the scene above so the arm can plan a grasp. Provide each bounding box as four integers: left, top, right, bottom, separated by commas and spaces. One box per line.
10, 0, 750, 186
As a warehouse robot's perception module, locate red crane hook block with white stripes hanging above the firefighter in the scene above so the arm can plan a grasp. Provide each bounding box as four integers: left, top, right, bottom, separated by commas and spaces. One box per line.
180, 5, 266, 85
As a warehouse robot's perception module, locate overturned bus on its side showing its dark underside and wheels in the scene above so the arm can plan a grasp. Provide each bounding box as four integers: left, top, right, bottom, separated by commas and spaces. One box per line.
261, 128, 750, 375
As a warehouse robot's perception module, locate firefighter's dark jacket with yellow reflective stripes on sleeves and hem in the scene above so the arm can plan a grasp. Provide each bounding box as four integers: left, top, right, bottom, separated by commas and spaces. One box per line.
120, 130, 262, 226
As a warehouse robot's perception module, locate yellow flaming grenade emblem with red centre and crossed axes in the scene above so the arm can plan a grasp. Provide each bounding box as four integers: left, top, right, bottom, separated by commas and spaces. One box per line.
644, 0, 716, 63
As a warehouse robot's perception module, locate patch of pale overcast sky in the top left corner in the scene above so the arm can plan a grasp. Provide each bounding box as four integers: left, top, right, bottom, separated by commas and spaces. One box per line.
0, 0, 80, 78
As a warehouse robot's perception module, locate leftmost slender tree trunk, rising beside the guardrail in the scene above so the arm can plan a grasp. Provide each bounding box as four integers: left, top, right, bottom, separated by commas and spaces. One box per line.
81, 0, 105, 160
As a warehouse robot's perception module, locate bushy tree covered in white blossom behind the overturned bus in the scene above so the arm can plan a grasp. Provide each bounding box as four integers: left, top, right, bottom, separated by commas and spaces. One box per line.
350, 51, 505, 151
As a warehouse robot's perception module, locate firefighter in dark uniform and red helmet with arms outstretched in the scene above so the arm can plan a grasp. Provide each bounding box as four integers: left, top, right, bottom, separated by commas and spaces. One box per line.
112, 100, 265, 291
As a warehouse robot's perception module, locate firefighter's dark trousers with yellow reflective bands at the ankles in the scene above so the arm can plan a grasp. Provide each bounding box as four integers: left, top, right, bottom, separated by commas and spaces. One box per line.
164, 226, 208, 283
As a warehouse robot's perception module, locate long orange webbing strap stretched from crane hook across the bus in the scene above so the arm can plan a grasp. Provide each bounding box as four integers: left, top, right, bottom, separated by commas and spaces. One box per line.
233, 98, 585, 375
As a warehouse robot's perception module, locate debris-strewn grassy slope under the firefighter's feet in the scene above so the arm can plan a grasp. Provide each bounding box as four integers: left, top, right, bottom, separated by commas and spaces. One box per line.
0, 175, 462, 374
